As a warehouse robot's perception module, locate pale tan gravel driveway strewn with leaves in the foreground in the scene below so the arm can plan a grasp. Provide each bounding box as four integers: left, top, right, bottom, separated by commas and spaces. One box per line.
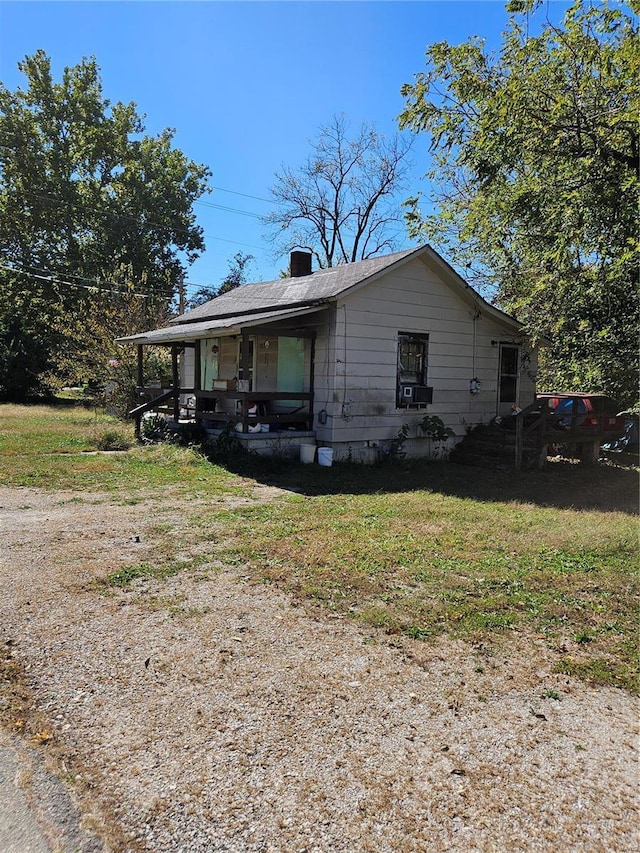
0, 488, 639, 853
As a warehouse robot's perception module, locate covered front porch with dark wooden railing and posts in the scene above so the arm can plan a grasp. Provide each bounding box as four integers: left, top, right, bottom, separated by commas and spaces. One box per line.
128, 324, 316, 449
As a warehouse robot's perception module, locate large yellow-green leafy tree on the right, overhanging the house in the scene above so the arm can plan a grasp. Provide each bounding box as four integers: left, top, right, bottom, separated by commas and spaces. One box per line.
400, 0, 640, 404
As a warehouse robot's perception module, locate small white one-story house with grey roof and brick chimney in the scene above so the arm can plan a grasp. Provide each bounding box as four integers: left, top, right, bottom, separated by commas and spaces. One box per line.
121, 246, 537, 462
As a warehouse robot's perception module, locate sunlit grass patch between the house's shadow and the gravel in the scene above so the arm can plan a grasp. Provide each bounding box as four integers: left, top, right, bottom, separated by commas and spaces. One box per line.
201, 476, 640, 692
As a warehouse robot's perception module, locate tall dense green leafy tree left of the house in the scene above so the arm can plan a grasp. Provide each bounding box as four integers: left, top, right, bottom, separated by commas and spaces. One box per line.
0, 51, 210, 397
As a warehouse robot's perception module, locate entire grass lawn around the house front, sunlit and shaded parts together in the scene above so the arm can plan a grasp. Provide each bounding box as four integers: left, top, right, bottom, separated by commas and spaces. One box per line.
0, 406, 640, 693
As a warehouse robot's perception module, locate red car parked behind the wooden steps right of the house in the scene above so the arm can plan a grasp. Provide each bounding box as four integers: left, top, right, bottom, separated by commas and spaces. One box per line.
536, 393, 625, 441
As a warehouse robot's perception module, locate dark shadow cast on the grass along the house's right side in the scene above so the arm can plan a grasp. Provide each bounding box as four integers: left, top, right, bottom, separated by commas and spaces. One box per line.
218, 456, 639, 515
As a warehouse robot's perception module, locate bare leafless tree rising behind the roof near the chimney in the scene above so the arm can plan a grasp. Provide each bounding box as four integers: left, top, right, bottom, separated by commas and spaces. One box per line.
265, 111, 411, 268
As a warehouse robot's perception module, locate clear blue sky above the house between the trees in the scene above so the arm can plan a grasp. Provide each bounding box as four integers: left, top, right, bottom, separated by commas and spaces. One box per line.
0, 0, 552, 296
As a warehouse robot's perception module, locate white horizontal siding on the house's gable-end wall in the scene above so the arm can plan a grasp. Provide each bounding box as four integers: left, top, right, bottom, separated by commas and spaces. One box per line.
316, 259, 535, 446
